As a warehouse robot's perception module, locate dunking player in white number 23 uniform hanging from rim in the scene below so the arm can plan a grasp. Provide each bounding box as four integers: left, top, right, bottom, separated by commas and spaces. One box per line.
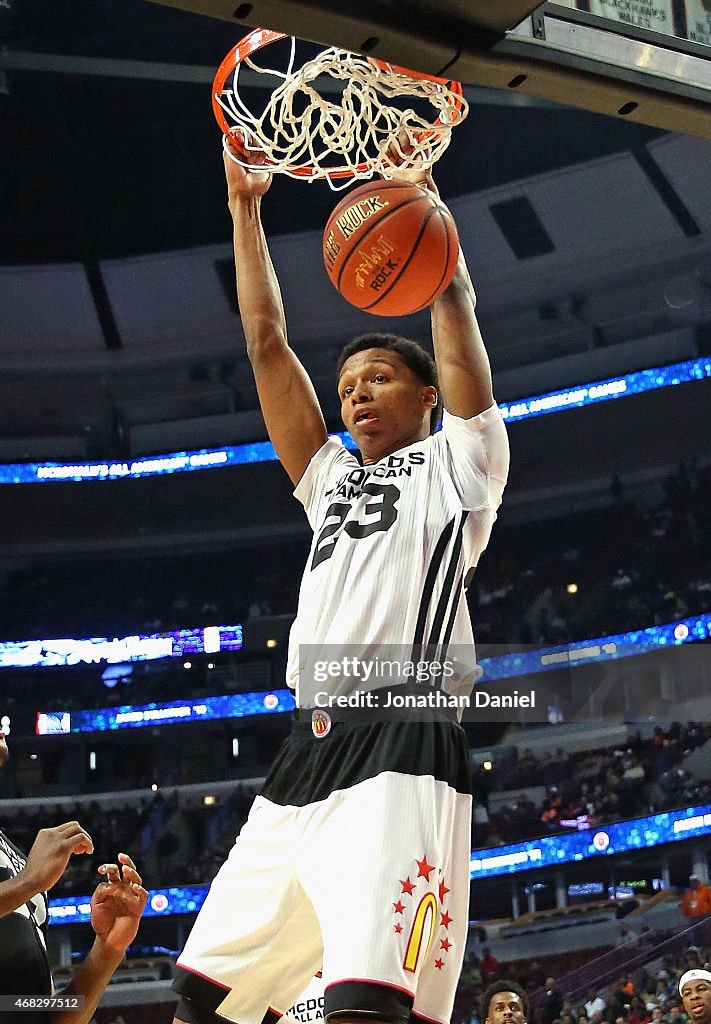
174, 142, 508, 1024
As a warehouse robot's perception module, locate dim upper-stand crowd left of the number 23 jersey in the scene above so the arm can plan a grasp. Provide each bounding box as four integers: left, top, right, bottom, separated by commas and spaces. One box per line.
0, 539, 308, 640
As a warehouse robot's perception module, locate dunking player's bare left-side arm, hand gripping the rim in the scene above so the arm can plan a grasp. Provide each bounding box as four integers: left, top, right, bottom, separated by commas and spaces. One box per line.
224, 143, 328, 483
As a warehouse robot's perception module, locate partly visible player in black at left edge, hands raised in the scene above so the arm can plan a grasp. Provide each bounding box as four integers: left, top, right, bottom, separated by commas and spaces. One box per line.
0, 731, 149, 1024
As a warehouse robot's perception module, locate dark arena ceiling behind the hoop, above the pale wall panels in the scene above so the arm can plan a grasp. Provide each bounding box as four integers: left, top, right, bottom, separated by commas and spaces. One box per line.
0, 0, 660, 265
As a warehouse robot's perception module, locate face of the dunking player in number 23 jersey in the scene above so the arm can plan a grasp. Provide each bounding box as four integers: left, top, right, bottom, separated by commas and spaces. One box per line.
338, 348, 436, 464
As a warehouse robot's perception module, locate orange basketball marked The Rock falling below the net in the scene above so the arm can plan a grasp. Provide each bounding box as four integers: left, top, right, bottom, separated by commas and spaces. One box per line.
324, 181, 459, 316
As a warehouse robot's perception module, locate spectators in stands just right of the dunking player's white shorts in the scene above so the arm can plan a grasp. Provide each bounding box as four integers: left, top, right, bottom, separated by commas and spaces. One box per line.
474, 722, 711, 847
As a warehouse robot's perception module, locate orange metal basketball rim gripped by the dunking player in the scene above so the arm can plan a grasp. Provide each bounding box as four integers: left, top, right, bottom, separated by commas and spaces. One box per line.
212, 29, 463, 178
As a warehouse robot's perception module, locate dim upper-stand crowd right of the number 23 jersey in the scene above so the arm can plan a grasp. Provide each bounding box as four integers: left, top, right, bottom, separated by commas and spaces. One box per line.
469, 463, 711, 645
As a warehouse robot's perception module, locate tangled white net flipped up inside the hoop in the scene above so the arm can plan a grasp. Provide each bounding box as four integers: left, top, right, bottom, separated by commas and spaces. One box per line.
215, 39, 468, 189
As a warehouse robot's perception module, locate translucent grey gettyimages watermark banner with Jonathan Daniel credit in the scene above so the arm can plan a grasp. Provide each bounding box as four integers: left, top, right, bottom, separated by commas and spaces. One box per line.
297, 637, 711, 731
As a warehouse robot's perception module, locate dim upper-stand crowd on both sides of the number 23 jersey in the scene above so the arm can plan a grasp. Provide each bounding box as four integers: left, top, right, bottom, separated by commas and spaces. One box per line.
0, 463, 711, 645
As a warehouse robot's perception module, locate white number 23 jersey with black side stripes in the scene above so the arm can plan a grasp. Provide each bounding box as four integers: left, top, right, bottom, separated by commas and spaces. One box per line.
287, 406, 509, 707
